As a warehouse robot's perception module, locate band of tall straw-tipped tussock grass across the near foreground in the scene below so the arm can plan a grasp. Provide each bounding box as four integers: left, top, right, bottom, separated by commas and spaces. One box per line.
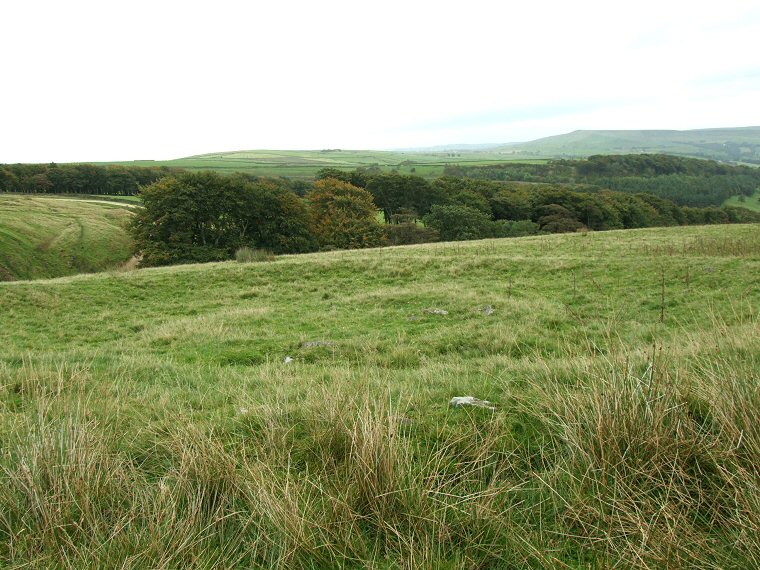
0, 338, 760, 568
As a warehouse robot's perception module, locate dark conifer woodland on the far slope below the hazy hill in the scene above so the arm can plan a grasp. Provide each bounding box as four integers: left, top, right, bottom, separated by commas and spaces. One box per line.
445, 154, 760, 207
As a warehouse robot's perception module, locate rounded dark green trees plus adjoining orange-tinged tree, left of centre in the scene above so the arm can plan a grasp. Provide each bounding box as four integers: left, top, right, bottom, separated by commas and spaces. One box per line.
132, 171, 384, 265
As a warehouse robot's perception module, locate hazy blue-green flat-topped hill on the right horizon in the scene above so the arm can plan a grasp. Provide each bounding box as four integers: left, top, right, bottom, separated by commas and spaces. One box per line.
494, 127, 760, 164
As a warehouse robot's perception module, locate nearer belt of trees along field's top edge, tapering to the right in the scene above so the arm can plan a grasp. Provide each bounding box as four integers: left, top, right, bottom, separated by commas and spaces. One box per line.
132, 165, 760, 265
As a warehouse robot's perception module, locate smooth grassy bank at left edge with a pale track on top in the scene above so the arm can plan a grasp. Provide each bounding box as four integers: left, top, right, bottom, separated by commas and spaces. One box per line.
0, 194, 132, 281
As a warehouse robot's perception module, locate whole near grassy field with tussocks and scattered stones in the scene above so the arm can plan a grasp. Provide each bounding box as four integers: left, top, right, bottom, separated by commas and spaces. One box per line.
0, 226, 760, 569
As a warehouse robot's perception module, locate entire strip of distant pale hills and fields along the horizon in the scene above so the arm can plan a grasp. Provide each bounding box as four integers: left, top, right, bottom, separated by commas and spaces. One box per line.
93, 127, 760, 179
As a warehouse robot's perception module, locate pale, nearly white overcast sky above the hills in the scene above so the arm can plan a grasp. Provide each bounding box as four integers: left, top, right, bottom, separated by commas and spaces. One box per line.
0, 0, 760, 163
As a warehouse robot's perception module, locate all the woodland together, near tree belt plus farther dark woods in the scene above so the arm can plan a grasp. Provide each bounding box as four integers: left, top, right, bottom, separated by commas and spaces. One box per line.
0, 155, 760, 265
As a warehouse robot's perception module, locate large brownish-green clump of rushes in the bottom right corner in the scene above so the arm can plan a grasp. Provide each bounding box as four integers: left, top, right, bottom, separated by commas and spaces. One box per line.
528, 348, 760, 569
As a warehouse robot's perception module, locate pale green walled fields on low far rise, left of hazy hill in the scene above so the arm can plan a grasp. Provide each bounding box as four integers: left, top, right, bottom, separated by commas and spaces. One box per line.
102, 150, 541, 179
